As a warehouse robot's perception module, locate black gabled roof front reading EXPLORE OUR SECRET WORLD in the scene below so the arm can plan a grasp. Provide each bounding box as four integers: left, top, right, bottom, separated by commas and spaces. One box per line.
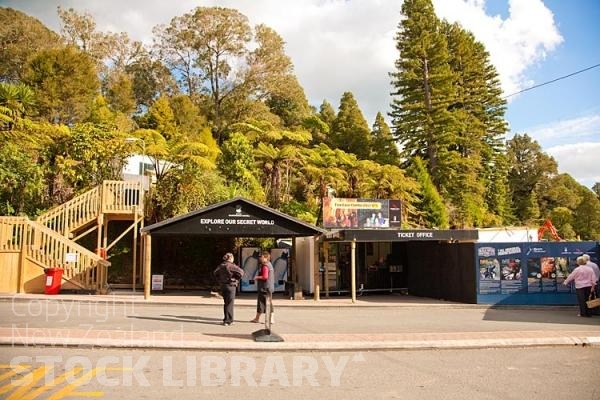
142, 197, 325, 238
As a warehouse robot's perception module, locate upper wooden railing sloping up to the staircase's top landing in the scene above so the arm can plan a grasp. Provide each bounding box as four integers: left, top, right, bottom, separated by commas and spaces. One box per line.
37, 181, 144, 237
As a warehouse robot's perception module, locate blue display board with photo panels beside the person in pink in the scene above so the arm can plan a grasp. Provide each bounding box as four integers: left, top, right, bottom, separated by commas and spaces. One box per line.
475, 242, 600, 305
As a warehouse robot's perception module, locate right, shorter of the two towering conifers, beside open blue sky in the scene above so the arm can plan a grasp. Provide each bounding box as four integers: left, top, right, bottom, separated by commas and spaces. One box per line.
442, 21, 509, 226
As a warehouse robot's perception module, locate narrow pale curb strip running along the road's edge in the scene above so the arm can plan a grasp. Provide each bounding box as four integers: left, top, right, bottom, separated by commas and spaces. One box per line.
0, 328, 600, 351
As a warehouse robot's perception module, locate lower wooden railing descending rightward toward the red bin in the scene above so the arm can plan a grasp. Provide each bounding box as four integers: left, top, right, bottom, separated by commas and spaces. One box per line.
0, 217, 110, 292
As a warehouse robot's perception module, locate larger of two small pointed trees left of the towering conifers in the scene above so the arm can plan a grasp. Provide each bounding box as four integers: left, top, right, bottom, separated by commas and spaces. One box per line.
329, 92, 371, 160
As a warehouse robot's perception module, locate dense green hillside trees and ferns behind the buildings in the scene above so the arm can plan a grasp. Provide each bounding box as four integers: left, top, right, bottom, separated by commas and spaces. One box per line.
0, 0, 600, 240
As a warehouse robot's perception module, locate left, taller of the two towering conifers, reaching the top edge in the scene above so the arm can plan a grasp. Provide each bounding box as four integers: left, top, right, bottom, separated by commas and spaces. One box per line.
390, 0, 457, 188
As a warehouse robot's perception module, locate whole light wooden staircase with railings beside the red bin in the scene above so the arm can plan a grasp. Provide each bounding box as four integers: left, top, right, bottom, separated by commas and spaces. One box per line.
0, 181, 144, 293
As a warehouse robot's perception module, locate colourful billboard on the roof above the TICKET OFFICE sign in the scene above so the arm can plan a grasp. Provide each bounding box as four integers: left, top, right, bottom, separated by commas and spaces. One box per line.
323, 197, 402, 229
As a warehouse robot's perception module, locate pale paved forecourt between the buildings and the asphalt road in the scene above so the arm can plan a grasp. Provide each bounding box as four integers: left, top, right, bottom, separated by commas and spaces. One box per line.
0, 292, 600, 351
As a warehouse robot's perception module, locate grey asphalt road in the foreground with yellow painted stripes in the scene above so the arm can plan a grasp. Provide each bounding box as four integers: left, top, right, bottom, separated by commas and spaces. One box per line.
0, 347, 600, 400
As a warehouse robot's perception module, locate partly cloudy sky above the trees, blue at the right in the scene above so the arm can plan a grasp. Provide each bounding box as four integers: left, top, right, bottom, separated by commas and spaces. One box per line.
0, 0, 600, 188
